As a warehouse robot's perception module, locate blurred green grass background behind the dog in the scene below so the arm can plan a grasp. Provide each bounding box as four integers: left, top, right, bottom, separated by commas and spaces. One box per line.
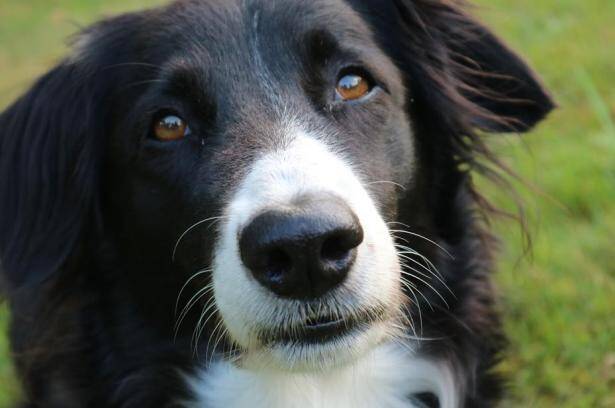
0, 0, 615, 407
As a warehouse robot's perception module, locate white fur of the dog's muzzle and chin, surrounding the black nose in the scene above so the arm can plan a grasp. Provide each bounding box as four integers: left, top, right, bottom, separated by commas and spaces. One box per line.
213, 127, 401, 368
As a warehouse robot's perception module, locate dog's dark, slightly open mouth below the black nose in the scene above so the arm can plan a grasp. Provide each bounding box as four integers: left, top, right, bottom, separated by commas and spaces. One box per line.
260, 309, 385, 346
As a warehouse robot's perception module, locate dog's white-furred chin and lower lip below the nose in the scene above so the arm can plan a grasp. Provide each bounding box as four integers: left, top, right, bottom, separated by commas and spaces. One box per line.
244, 320, 388, 372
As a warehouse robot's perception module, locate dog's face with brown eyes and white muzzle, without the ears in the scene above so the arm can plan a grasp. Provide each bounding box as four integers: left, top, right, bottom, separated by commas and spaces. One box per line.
106, 0, 414, 366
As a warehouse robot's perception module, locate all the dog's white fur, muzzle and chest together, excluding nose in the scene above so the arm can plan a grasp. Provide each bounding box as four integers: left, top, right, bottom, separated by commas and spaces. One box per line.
192, 126, 459, 408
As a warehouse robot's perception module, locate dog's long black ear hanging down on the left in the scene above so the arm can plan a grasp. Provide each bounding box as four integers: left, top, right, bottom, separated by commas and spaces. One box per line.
0, 9, 148, 288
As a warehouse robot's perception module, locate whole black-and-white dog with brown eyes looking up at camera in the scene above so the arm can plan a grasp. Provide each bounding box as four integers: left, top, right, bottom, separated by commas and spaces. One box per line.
0, 0, 554, 408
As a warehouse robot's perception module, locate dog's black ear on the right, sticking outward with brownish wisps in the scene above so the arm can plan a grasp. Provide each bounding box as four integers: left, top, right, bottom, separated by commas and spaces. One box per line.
352, 0, 554, 132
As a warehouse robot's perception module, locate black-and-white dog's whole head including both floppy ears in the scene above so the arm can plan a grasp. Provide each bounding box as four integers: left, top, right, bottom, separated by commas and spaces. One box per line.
0, 0, 552, 367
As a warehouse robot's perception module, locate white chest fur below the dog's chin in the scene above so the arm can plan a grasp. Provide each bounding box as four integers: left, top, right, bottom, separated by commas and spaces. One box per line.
186, 344, 457, 408
